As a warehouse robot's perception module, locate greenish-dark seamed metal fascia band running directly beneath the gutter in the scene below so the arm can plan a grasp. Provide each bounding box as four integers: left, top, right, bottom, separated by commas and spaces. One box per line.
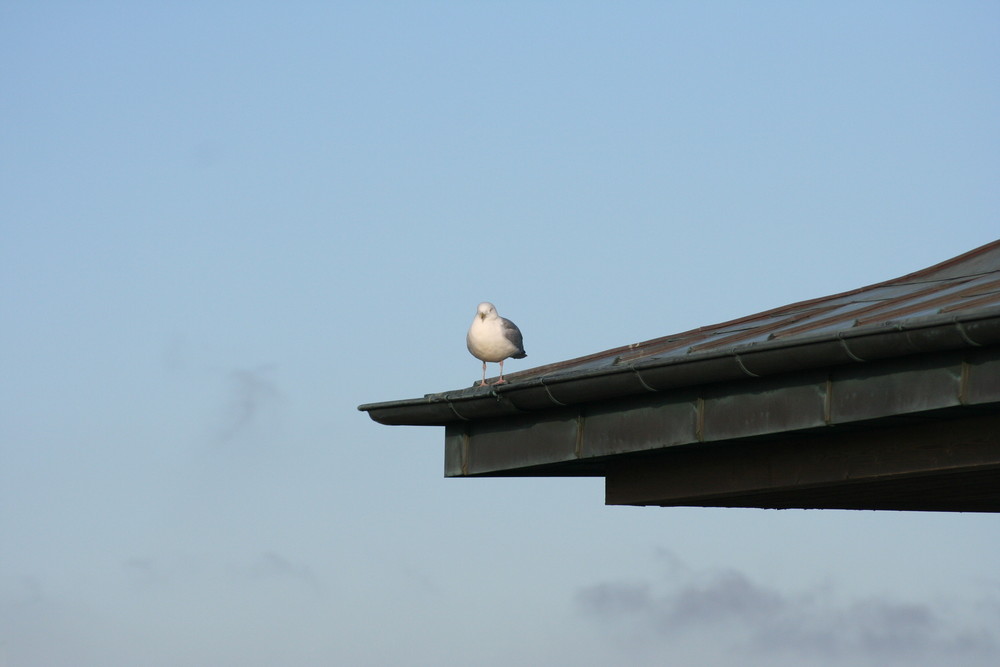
446, 348, 1000, 476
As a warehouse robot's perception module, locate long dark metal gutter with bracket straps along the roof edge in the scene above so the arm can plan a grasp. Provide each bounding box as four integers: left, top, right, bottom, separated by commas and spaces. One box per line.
358, 308, 1000, 426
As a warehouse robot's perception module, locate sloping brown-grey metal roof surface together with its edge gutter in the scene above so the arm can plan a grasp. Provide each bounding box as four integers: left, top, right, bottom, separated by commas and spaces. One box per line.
359, 241, 1000, 425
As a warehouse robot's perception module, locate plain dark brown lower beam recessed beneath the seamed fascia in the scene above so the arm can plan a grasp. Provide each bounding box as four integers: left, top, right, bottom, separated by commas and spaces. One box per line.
606, 414, 1000, 511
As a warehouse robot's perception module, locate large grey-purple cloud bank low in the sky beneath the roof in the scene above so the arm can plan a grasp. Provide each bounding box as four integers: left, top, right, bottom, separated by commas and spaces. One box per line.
575, 562, 1000, 664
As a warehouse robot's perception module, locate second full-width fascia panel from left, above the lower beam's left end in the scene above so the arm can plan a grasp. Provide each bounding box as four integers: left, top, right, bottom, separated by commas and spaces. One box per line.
580, 394, 698, 458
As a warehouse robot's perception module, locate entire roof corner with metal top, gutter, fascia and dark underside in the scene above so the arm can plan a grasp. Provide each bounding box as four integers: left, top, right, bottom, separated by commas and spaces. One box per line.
360, 242, 1000, 512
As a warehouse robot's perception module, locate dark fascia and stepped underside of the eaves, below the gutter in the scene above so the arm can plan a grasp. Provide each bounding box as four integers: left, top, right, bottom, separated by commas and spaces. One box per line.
445, 346, 1000, 511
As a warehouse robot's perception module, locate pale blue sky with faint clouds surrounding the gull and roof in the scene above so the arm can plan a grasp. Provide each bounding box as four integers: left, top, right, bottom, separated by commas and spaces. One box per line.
0, 2, 1000, 667
